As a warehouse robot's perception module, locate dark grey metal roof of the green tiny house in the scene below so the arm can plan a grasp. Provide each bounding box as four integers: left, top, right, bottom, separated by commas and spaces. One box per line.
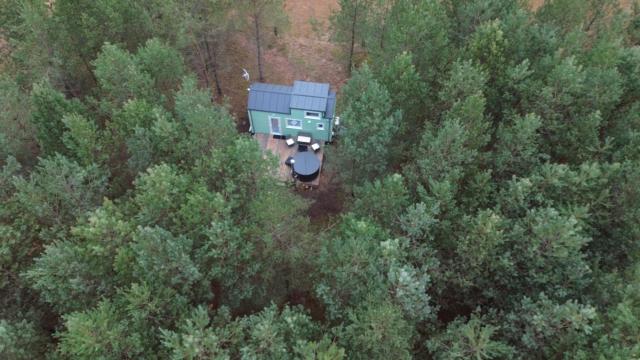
247, 80, 336, 118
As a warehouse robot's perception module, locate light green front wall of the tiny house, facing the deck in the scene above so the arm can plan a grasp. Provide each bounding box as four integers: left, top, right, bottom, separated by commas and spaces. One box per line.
249, 109, 333, 141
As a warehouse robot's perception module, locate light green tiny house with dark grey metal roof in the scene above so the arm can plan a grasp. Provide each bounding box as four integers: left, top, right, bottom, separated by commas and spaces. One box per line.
247, 80, 336, 141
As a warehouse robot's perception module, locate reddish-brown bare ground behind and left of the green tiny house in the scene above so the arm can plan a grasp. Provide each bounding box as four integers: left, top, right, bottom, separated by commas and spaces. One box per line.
216, 0, 347, 130
